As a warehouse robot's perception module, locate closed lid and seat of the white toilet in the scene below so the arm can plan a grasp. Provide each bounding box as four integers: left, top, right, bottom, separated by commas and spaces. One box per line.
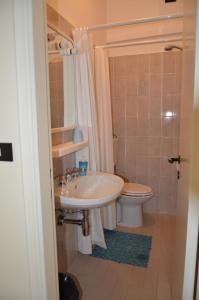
122, 182, 153, 195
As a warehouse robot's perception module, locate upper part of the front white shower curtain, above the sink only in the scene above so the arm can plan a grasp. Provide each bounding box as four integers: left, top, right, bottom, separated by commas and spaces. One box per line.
73, 28, 100, 171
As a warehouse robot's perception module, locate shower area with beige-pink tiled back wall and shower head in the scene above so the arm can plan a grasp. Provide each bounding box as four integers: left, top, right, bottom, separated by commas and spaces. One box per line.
90, 14, 183, 216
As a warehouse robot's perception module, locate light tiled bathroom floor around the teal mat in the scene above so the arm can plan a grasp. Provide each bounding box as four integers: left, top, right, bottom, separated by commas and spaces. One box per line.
69, 215, 175, 300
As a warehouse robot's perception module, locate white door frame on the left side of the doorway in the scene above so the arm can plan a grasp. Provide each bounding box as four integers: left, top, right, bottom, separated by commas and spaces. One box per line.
13, 0, 59, 300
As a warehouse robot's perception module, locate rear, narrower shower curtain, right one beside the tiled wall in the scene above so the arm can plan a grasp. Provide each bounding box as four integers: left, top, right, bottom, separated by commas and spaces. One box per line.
95, 48, 116, 230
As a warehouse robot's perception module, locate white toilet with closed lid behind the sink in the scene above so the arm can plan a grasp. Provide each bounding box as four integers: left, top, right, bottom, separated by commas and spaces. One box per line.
117, 183, 153, 227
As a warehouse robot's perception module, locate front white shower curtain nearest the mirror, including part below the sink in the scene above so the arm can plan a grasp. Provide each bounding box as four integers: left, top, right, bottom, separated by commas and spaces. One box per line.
73, 29, 106, 254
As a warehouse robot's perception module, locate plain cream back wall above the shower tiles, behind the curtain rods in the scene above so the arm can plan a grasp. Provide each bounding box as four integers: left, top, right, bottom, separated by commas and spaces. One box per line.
107, 0, 183, 56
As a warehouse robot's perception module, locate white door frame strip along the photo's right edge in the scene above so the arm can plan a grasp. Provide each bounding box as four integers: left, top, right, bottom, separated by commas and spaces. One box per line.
182, 0, 199, 300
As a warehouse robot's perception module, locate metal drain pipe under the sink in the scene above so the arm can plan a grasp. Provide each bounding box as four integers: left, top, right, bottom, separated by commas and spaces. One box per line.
57, 209, 90, 236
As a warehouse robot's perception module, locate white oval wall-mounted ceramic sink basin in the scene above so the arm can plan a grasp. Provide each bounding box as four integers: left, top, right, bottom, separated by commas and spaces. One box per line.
56, 172, 124, 209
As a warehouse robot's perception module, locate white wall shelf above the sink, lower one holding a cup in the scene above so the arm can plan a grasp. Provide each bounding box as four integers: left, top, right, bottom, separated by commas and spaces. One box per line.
52, 141, 88, 158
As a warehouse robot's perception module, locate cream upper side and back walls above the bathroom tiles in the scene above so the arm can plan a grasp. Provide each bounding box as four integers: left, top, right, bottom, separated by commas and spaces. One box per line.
48, 0, 182, 56
